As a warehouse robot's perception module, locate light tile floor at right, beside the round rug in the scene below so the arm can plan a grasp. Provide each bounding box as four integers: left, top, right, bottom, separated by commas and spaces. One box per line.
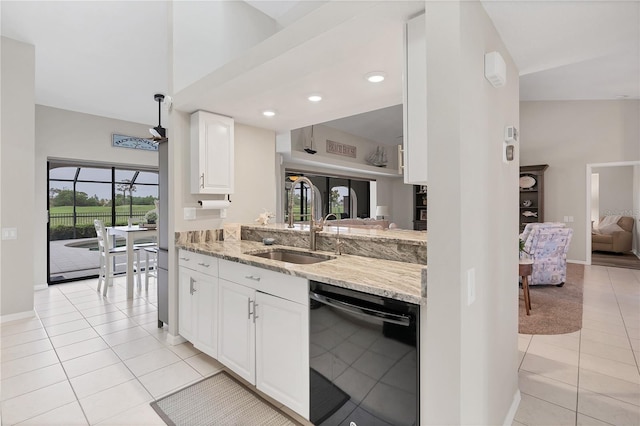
513, 266, 640, 426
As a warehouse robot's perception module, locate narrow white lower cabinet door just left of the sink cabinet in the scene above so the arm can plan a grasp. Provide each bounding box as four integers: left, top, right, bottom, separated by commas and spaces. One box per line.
191, 272, 218, 358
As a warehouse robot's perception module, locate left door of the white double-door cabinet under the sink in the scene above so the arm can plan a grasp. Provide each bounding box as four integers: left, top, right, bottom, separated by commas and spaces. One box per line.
218, 279, 256, 384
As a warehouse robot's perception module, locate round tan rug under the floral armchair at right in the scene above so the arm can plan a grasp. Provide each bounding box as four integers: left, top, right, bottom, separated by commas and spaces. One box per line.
518, 263, 584, 334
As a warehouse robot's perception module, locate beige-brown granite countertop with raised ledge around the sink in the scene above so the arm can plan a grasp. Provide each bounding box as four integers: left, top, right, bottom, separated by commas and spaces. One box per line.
176, 224, 427, 304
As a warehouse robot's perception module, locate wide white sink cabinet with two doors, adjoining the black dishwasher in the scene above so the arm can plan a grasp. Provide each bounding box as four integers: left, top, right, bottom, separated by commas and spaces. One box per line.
218, 260, 309, 418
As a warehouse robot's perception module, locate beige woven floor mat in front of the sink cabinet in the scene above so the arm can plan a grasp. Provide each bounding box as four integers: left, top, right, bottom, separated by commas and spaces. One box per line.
151, 371, 298, 426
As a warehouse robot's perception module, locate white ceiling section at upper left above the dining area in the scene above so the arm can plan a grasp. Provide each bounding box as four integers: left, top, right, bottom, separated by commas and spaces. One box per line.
0, 1, 169, 125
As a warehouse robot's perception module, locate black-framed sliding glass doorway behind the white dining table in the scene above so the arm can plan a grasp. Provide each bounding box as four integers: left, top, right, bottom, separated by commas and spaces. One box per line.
47, 160, 158, 284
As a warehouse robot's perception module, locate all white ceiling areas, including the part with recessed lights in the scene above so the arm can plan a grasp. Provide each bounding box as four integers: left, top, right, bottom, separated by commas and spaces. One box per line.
0, 0, 640, 143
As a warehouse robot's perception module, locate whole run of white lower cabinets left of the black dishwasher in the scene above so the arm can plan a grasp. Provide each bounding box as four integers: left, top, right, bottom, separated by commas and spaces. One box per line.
178, 255, 309, 419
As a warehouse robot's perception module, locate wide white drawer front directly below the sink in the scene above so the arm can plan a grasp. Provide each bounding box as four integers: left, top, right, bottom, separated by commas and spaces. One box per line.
219, 259, 309, 306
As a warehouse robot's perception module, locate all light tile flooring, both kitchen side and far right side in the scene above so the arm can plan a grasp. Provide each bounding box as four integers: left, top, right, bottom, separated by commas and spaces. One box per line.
0, 266, 640, 426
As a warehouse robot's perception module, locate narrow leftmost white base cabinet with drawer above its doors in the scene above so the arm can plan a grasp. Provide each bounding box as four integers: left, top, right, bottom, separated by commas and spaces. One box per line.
178, 250, 218, 358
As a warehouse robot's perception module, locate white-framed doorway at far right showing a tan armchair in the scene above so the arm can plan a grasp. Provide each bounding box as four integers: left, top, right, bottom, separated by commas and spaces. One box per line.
585, 161, 640, 269
